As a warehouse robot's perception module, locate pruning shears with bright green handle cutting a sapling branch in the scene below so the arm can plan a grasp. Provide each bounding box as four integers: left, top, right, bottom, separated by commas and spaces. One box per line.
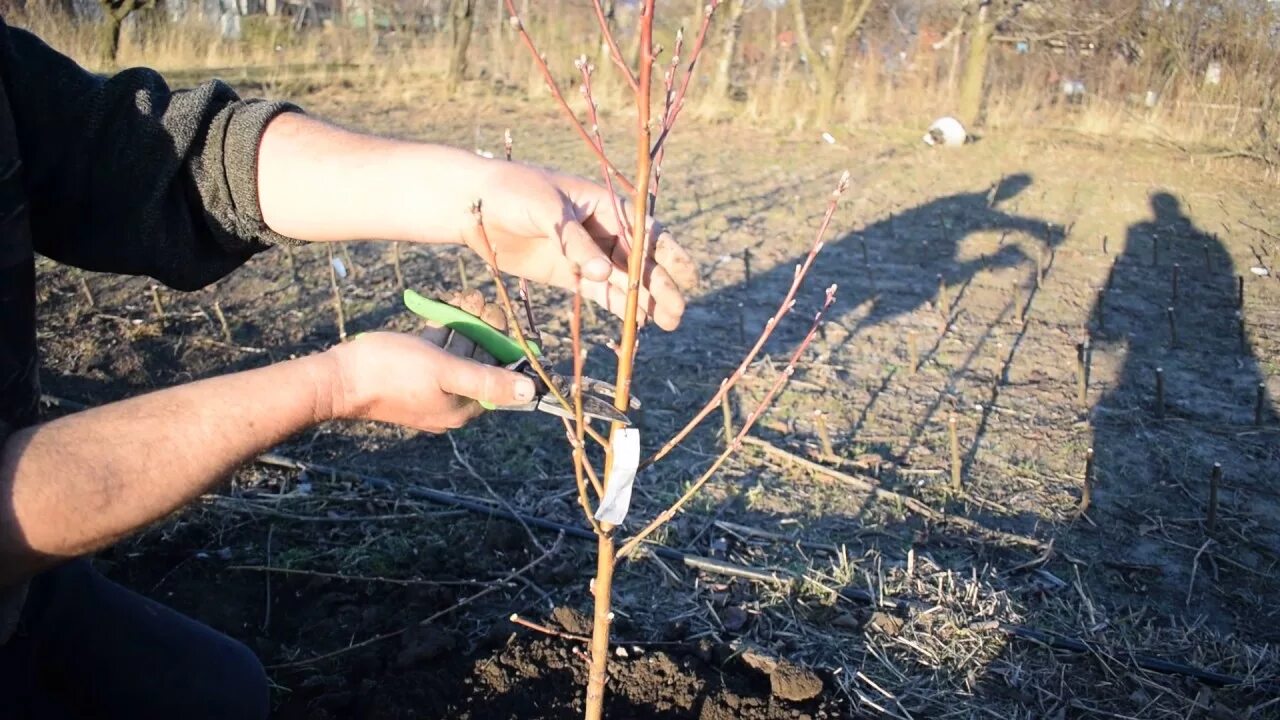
404, 290, 640, 425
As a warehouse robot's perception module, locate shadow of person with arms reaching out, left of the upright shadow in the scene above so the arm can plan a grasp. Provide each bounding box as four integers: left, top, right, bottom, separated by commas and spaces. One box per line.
641, 173, 1064, 386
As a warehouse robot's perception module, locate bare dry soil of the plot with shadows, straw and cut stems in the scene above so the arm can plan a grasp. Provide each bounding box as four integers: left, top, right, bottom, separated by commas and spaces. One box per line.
32, 81, 1280, 719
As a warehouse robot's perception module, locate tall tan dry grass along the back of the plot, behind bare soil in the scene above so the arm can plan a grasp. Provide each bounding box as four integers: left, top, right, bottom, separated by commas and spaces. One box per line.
9, 5, 1276, 156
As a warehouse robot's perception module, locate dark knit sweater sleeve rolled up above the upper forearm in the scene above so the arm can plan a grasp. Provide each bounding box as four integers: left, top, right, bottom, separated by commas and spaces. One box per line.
0, 23, 297, 290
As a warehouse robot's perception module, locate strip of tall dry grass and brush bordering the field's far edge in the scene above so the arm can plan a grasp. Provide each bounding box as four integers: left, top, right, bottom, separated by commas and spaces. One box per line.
9, 0, 1277, 160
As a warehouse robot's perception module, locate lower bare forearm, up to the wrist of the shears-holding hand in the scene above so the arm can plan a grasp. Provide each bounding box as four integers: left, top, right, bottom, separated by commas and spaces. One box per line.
0, 354, 338, 587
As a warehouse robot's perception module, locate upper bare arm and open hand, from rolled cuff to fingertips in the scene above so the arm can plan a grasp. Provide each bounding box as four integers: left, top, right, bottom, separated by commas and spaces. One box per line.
256, 113, 698, 329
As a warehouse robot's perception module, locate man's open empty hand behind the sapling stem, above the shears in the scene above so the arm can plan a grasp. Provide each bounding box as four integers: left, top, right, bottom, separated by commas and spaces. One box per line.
465, 161, 698, 331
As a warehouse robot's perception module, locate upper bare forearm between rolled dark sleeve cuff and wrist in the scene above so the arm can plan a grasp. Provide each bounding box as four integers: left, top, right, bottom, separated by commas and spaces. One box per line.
257, 114, 493, 242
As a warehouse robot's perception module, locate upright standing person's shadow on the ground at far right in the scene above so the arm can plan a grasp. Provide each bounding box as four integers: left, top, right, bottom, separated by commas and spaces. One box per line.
1089, 192, 1280, 610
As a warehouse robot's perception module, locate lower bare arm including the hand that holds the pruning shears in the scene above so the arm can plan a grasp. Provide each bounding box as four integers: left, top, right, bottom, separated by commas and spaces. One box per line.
0, 333, 532, 588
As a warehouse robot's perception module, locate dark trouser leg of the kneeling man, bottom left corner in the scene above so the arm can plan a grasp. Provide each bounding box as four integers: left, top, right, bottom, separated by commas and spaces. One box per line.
0, 560, 270, 720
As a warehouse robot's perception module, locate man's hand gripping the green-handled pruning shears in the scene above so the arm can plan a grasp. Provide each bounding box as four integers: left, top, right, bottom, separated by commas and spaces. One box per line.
329, 290, 534, 433
